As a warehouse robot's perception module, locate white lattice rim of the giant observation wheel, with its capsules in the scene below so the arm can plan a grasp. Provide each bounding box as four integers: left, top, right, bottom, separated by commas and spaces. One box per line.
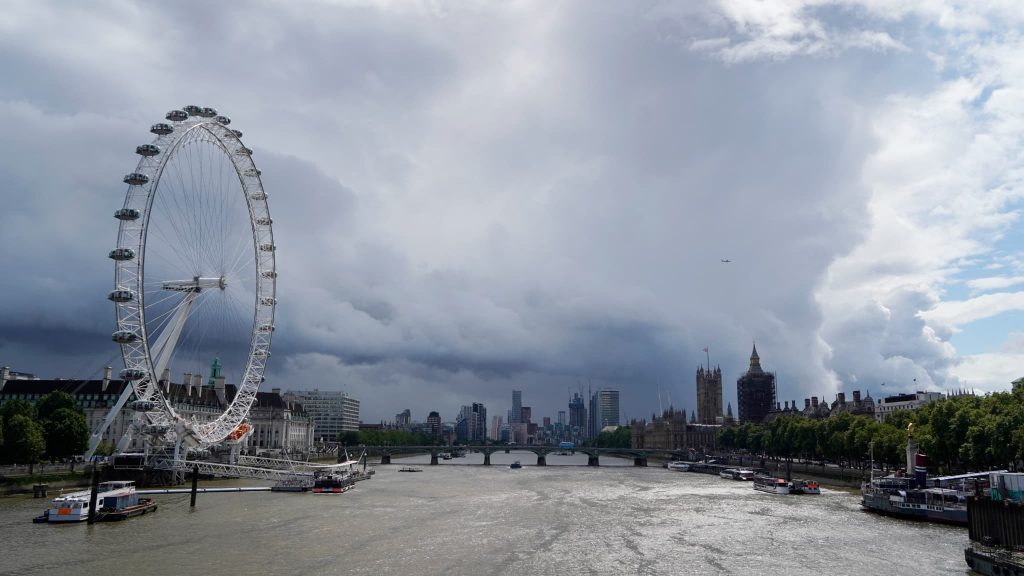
109, 107, 276, 445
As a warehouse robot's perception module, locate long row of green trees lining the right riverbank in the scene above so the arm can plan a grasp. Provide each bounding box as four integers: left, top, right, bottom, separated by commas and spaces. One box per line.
718, 378, 1024, 474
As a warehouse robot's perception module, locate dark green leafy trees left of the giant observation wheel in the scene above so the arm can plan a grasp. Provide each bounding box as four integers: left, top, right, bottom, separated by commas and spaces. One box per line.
0, 392, 89, 472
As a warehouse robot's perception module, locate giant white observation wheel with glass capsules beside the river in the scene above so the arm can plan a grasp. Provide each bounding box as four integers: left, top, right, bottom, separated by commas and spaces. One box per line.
108, 106, 278, 447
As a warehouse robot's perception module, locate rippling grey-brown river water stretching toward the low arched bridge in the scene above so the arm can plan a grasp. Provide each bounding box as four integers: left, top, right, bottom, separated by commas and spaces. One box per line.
0, 453, 968, 576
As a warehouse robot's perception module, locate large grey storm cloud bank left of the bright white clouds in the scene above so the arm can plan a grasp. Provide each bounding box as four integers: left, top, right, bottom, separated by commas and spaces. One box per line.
0, 2, 1003, 420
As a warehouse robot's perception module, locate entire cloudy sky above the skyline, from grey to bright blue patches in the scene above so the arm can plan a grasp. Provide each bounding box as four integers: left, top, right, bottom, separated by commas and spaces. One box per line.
0, 0, 1024, 421
